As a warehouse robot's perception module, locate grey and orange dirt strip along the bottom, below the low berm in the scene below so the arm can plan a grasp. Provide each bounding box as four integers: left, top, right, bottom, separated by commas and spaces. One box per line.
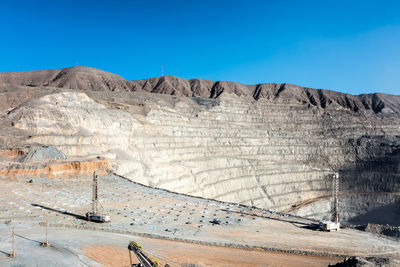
0, 225, 340, 266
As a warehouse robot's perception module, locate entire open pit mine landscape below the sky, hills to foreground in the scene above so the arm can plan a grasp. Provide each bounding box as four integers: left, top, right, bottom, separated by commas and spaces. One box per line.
0, 67, 400, 266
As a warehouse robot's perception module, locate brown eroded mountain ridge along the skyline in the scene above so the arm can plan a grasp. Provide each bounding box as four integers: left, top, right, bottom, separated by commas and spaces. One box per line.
0, 67, 400, 114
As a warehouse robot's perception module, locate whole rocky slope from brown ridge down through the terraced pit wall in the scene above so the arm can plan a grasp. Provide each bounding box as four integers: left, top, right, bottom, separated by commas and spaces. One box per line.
0, 67, 400, 225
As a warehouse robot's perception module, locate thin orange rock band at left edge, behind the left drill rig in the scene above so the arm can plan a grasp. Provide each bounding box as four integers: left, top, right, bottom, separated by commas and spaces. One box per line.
0, 160, 110, 178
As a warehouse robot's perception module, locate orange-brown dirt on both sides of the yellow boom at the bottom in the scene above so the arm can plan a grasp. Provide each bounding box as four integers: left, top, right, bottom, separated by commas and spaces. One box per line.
84, 245, 340, 267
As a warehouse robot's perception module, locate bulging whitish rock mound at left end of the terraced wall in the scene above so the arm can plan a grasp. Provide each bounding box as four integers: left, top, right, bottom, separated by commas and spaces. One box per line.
6, 92, 141, 163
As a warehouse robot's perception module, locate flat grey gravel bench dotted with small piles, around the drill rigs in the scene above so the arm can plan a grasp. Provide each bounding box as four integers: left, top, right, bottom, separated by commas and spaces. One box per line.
0, 175, 400, 266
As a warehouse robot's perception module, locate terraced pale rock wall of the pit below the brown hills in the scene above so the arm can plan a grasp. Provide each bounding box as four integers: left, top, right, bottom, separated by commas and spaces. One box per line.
3, 92, 400, 222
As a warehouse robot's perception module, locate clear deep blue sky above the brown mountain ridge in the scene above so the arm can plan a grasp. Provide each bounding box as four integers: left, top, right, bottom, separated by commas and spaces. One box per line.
0, 0, 400, 94
